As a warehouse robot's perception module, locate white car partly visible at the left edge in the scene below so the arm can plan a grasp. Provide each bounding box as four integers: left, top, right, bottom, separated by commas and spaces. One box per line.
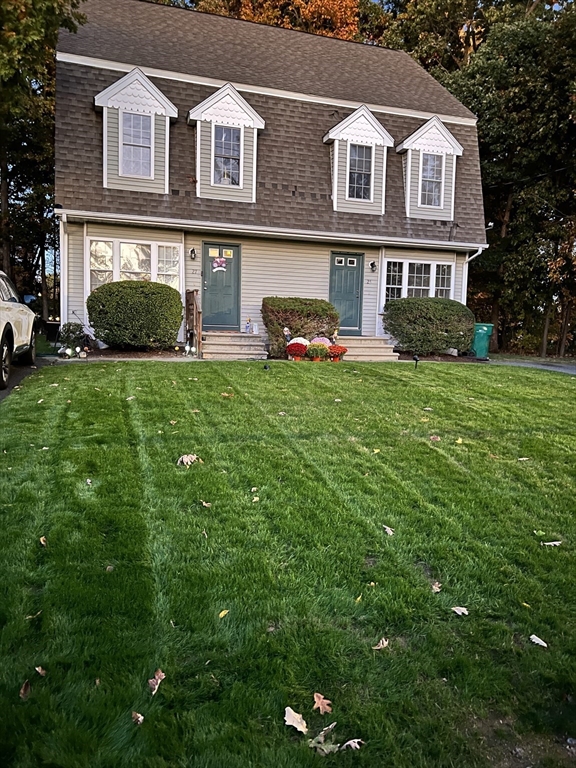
0, 271, 36, 389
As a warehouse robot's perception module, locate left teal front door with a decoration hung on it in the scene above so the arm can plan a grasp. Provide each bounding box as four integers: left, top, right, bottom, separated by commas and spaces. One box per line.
202, 243, 240, 331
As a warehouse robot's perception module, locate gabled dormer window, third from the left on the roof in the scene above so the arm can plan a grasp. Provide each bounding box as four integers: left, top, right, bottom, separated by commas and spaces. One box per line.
324, 105, 394, 216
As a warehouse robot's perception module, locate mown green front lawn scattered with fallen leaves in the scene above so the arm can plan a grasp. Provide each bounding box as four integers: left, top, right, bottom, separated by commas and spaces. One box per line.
0, 362, 576, 768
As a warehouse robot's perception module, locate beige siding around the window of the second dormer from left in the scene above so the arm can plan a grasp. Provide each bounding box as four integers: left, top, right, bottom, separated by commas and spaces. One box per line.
196, 120, 255, 203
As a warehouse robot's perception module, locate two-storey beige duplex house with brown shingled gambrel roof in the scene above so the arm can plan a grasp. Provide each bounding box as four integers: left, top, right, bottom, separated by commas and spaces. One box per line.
56, 0, 486, 359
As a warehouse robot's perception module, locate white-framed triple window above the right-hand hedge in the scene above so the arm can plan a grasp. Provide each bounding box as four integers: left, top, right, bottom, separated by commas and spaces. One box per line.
384, 261, 453, 302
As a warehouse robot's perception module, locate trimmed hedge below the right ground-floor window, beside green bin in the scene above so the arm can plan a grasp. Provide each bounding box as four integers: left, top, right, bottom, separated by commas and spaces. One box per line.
383, 298, 474, 355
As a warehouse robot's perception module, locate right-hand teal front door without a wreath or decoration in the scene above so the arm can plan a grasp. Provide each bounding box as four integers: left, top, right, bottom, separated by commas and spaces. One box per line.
330, 252, 364, 336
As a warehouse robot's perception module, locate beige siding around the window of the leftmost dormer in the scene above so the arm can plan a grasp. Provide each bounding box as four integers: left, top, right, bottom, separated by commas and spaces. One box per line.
105, 108, 167, 194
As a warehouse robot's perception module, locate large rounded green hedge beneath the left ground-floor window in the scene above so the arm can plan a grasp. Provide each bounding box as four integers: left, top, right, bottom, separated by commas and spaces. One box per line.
86, 280, 182, 349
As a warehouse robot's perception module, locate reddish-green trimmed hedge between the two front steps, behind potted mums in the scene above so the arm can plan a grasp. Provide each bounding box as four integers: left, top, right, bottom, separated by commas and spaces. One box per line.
262, 296, 340, 358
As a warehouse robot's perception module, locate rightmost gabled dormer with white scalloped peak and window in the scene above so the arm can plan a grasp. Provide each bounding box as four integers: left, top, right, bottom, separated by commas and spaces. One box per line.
396, 116, 463, 221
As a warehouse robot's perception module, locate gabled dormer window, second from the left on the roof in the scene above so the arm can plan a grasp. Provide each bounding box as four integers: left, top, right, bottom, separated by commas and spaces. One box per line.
188, 83, 265, 203
